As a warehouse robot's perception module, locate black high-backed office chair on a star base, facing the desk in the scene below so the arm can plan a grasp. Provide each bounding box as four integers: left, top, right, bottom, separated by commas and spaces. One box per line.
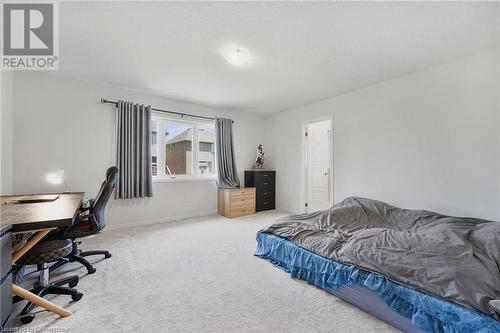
48, 166, 118, 274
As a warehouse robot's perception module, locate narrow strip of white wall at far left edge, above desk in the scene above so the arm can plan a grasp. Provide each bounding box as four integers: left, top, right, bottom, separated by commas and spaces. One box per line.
0, 71, 14, 195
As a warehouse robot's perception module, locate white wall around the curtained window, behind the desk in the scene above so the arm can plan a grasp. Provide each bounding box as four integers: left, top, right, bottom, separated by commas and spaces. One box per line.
10, 72, 264, 226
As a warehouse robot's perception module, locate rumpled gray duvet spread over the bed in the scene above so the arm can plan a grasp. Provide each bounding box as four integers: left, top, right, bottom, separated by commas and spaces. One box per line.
264, 198, 500, 320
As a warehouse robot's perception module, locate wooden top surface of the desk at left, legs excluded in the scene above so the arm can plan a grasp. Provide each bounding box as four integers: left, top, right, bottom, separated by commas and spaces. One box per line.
0, 192, 84, 232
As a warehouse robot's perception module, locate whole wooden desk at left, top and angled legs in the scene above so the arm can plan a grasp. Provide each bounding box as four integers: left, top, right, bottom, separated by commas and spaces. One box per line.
0, 192, 84, 317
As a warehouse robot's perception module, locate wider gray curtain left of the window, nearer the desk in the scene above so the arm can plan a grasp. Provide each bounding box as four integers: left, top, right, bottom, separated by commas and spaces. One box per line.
115, 101, 153, 199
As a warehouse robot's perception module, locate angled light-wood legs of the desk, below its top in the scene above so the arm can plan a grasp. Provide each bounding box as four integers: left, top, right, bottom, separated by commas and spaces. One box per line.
12, 229, 71, 317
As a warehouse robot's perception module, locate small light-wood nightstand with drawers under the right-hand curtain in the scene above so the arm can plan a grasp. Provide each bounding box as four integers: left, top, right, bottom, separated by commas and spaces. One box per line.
218, 187, 255, 219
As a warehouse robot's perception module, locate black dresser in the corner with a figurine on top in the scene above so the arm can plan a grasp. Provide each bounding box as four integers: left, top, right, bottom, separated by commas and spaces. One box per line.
245, 170, 276, 212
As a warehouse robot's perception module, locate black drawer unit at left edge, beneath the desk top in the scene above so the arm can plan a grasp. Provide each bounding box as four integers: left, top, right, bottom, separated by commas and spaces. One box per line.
0, 225, 12, 332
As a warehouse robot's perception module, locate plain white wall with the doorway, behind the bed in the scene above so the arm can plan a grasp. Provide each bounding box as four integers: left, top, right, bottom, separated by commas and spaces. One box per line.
267, 51, 500, 220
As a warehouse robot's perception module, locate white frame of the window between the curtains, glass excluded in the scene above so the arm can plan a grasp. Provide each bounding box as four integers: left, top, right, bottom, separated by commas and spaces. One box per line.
150, 111, 217, 182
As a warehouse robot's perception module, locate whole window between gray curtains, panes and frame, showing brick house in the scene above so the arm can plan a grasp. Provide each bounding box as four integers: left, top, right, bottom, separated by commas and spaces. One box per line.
151, 113, 215, 180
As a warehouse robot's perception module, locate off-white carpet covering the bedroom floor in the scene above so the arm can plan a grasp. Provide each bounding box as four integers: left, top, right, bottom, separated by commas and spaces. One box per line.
14, 212, 397, 333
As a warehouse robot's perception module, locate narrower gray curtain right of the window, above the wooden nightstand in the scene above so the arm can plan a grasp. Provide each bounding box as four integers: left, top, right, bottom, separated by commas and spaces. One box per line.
215, 118, 240, 188
